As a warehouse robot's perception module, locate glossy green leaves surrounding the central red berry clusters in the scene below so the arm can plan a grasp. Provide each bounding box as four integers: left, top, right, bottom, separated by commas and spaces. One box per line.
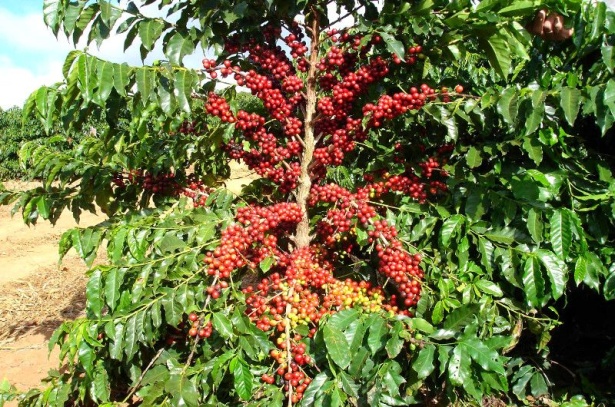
0, 0, 615, 406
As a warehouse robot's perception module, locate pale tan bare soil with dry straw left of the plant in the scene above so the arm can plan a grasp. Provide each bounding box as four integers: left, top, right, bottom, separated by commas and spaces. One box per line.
0, 183, 104, 398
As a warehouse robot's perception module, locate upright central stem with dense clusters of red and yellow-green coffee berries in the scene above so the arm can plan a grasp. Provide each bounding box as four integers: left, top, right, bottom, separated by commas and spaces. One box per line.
195, 11, 460, 406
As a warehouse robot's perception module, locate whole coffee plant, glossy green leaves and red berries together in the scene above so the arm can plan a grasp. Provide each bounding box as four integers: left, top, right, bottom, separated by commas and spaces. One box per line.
0, 0, 615, 406
